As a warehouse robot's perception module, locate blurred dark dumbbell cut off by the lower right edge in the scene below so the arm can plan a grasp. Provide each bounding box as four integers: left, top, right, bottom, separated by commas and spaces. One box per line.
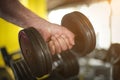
106, 43, 120, 80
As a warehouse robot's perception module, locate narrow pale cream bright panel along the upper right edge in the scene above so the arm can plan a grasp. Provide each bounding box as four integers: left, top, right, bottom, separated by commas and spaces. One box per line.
111, 0, 120, 43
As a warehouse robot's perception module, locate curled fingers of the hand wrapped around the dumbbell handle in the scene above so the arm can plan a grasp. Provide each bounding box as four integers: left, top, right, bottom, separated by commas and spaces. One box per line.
49, 34, 72, 54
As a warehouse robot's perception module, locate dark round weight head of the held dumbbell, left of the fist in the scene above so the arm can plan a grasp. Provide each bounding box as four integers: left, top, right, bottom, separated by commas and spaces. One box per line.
19, 27, 52, 77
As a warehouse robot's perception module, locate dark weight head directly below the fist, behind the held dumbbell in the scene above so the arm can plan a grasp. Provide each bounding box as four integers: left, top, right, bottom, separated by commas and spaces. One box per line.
58, 51, 80, 78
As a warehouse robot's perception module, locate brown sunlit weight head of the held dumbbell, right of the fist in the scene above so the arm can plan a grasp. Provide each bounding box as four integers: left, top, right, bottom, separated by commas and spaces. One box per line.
61, 12, 96, 56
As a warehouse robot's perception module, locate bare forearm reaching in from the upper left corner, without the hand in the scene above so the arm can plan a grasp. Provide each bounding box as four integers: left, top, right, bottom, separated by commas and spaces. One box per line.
0, 0, 47, 28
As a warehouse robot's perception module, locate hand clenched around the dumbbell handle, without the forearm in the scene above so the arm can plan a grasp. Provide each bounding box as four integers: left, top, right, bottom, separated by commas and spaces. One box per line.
34, 23, 75, 54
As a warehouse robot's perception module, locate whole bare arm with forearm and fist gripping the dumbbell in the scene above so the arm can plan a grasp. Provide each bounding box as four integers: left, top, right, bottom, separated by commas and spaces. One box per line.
0, 0, 75, 54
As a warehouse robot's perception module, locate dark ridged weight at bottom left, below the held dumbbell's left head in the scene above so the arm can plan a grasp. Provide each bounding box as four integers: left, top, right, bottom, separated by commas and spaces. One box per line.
11, 60, 36, 80
